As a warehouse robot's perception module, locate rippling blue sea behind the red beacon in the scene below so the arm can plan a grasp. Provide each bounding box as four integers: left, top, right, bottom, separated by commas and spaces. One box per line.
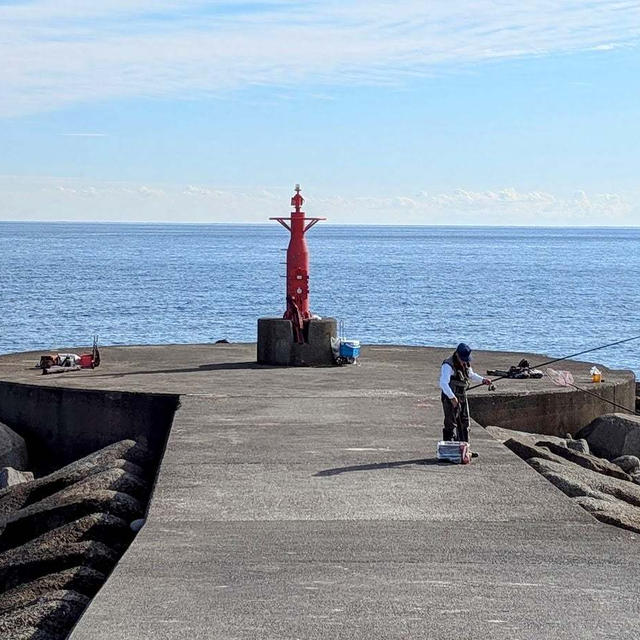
0, 222, 640, 374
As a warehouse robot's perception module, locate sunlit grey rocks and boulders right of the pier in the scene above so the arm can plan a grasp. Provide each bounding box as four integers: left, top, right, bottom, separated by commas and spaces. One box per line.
487, 414, 640, 533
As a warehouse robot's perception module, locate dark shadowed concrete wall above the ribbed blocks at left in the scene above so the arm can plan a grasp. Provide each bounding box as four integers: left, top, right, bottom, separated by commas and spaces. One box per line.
0, 382, 179, 473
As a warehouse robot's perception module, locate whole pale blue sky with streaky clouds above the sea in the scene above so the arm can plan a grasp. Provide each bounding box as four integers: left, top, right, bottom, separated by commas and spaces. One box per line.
0, 0, 640, 225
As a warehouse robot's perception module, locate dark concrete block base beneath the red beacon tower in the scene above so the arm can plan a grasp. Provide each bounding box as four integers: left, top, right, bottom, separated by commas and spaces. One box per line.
258, 318, 338, 367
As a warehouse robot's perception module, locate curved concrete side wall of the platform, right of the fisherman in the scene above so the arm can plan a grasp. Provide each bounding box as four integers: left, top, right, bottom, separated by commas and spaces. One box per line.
469, 374, 636, 436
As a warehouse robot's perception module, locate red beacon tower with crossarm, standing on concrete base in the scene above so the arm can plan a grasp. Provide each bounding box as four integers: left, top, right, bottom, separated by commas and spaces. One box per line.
270, 184, 326, 342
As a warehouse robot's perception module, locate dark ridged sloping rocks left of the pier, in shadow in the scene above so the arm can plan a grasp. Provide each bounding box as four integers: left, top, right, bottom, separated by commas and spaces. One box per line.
0, 432, 153, 640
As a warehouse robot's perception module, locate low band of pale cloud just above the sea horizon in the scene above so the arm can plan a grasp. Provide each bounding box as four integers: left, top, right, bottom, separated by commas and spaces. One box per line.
0, 176, 640, 226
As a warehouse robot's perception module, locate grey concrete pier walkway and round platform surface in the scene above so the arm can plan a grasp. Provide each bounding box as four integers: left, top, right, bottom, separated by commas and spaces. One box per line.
0, 344, 640, 640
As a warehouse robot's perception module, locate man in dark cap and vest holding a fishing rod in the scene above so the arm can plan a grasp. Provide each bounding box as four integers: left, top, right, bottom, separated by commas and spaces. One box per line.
440, 342, 491, 442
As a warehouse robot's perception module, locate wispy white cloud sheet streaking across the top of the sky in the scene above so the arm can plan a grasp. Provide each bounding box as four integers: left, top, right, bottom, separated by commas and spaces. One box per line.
0, 0, 640, 116
